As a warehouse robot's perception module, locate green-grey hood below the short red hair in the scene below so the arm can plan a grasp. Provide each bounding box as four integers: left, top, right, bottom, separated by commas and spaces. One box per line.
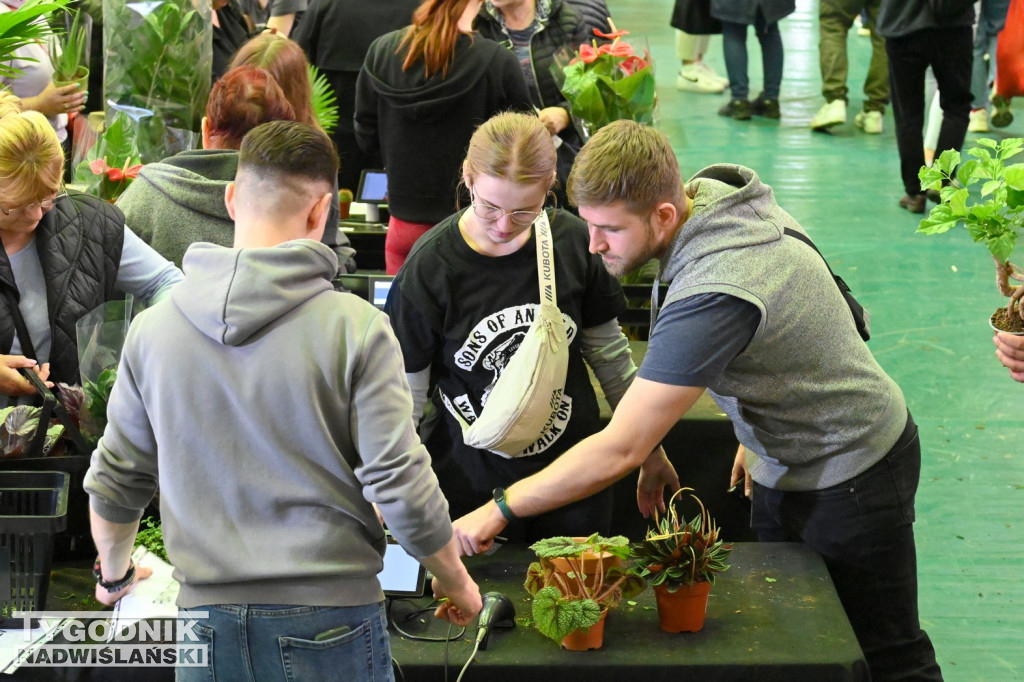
129, 150, 239, 222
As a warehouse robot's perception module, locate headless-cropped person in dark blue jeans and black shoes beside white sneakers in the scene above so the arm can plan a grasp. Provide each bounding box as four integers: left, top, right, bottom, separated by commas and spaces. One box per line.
711, 0, 796, 121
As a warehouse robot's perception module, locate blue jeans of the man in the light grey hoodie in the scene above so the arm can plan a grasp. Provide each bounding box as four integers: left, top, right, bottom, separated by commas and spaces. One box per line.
175, 602, 394, 682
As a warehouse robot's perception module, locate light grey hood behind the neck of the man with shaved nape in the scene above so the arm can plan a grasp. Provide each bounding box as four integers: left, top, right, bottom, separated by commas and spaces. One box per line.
171, 240, 338, 346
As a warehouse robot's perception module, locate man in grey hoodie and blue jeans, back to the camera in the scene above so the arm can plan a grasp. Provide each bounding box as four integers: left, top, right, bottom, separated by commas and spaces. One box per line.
85, 121, 480, 679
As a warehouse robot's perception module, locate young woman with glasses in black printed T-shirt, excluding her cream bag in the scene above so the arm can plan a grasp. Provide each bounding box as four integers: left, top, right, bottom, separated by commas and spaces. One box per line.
385, 114, 636, 542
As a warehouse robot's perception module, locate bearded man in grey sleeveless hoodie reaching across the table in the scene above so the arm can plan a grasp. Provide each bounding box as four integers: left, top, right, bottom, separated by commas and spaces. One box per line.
455, 121, 942, 680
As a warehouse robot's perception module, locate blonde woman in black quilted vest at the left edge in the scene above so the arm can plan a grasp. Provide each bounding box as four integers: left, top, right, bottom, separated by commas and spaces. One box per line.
0, 103, 182, 402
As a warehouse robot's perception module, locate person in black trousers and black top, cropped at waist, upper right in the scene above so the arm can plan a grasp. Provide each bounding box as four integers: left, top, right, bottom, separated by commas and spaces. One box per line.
878, 0, 974, 213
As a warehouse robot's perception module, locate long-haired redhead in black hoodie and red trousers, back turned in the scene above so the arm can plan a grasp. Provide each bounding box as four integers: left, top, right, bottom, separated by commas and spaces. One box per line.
355, 0, 530, 274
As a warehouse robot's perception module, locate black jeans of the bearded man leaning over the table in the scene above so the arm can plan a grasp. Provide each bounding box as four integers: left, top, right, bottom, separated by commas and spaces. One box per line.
751, 415, 942, 682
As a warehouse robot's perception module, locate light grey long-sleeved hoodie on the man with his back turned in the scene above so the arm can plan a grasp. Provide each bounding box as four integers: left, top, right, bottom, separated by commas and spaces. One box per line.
85, 240, 452, 607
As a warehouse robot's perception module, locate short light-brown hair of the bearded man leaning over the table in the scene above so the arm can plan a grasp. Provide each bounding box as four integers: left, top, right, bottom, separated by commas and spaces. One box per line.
566, 121, 686, 215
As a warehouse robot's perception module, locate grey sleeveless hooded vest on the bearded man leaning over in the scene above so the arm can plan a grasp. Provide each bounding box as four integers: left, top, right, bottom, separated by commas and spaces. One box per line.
662, 164, 907, 491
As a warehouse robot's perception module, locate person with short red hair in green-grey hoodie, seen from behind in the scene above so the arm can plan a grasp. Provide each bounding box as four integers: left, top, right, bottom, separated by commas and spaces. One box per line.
118, 62, 355, 269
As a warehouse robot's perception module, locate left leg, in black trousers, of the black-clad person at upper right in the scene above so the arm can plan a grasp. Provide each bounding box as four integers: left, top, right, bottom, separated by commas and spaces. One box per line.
886, 29, 937, 213
